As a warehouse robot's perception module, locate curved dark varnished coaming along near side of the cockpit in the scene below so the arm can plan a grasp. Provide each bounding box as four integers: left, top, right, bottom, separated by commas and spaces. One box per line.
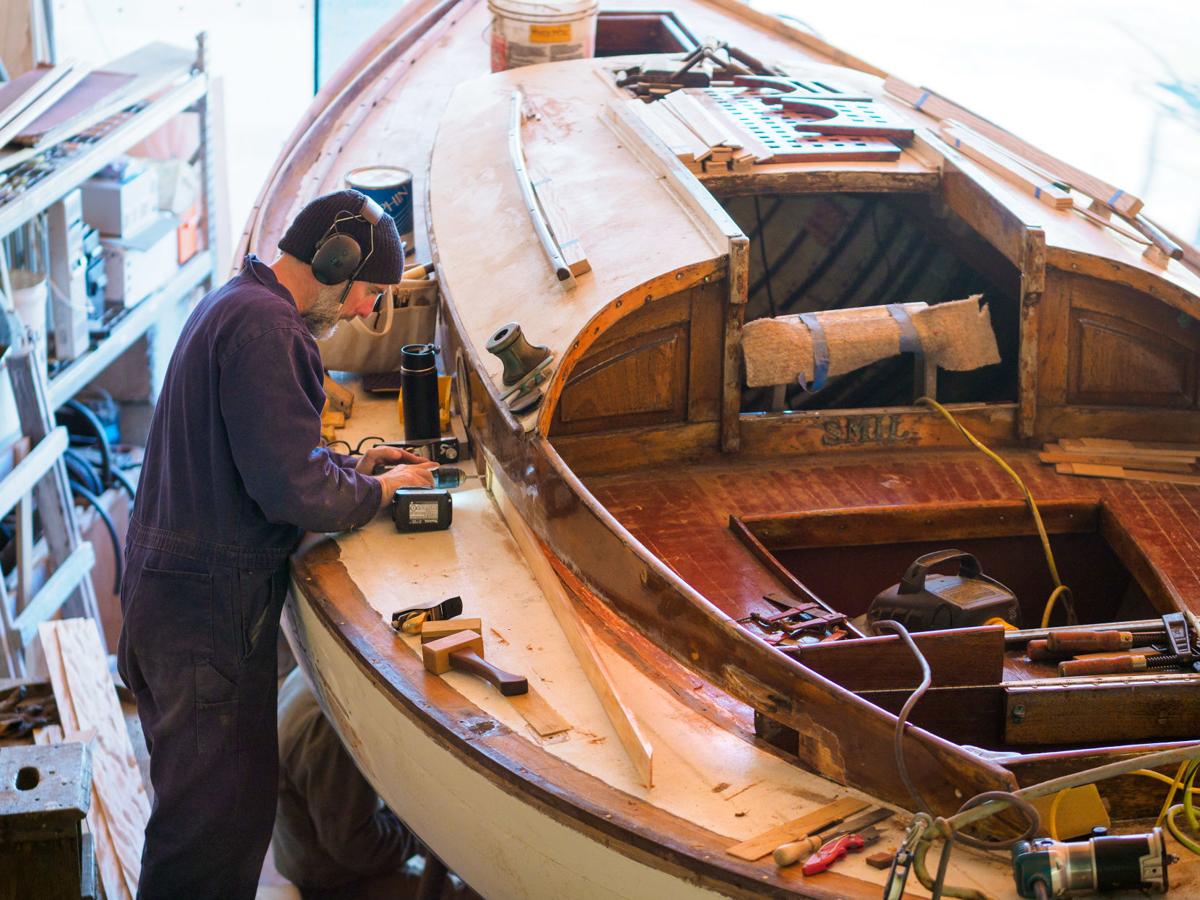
520, 438, 1014, 809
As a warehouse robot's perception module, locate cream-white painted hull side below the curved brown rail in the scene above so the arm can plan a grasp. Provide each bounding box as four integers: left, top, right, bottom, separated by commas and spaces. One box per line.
286, 587, 718, 900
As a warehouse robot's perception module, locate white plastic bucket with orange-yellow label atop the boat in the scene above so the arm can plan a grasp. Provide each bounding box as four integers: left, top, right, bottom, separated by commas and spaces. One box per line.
487, 0, 599, 72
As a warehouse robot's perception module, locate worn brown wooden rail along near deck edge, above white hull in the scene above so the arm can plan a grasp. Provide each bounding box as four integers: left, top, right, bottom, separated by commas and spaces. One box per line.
290, 538, 878, 900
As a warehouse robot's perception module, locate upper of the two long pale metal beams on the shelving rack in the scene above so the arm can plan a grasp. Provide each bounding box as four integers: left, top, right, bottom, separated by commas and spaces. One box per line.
0, 72, 208, 238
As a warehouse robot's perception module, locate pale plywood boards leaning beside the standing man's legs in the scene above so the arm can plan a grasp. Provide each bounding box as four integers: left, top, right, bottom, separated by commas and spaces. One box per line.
38, 619, 150, 900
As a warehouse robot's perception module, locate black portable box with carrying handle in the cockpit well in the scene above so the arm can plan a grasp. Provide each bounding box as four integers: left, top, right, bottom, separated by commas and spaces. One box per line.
866, 550, 1021, 631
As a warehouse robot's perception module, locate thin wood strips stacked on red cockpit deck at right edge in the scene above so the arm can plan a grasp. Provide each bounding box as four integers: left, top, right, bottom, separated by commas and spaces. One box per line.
1038, 438, 1200, 485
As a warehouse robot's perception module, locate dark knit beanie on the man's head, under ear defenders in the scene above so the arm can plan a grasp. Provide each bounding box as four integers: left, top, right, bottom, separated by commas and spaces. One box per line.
280, 191, 404, 284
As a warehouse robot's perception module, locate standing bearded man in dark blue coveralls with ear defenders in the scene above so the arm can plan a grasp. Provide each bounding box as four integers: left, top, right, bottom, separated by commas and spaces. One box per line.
119, 191, 433, 900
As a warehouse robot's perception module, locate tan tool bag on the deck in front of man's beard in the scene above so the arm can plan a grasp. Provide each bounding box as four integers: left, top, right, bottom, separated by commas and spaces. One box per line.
317, 282, 438, 374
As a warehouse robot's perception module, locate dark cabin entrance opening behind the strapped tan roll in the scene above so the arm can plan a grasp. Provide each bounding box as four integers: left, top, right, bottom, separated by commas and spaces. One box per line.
722, 193, 1020, 413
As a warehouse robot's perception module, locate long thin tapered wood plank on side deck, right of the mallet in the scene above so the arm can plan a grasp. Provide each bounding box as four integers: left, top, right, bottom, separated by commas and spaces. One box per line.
492, 472, 654, 787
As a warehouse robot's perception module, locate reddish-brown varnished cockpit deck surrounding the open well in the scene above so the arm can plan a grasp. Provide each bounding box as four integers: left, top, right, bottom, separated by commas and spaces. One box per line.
586, 450, 1200, 617
